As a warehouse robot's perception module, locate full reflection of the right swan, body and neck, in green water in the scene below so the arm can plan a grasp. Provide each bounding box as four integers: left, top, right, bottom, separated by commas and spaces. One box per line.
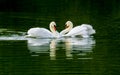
65, 38, 95, 59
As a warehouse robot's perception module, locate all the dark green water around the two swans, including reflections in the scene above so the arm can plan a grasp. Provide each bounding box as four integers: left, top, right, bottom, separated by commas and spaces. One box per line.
0, 0, 120, 75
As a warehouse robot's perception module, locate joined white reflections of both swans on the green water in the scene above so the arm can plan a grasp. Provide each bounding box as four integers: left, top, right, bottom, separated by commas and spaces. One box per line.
28, 38, 95, 60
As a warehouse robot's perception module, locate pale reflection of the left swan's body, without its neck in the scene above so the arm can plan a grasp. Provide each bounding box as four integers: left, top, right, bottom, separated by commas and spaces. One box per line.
27, 38, 51, 53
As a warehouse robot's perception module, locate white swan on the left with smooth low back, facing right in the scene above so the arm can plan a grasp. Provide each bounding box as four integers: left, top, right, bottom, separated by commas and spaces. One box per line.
26, 21, 59, 38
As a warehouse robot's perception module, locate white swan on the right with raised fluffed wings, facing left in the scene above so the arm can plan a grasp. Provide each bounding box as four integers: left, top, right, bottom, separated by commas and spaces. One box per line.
60, 21, 96, 38
